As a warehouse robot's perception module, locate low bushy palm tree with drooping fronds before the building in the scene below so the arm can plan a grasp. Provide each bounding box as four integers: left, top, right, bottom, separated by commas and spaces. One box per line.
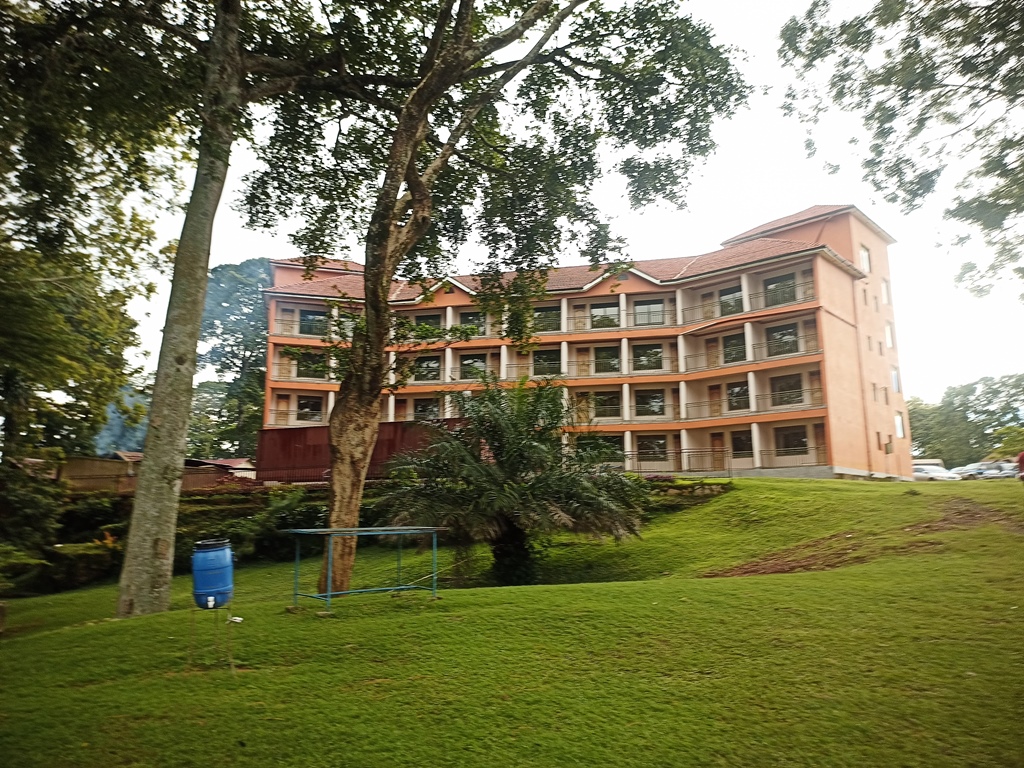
378, 380, 645, 585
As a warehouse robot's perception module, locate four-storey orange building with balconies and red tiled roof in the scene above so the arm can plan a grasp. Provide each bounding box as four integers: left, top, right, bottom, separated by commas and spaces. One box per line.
264, 206, 911, 478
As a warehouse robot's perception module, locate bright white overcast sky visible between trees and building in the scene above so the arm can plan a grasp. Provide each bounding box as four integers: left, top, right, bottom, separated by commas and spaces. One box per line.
133, 0, 1024, 401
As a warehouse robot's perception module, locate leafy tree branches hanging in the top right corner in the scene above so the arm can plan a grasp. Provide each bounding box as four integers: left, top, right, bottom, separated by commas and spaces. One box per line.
779, 0, 1024, 293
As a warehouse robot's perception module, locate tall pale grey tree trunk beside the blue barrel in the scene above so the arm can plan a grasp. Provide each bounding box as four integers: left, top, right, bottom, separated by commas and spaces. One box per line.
118, 0, 243, 617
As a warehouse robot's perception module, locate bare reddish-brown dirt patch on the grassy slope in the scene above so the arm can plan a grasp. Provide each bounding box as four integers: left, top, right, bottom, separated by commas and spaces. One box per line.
703, 499, 1024, 579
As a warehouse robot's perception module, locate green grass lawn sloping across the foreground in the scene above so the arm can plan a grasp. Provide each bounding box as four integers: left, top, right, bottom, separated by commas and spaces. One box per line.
0, 480, 1024, 768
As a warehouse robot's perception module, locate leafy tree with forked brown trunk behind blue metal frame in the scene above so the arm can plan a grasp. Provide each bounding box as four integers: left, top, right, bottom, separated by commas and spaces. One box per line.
246, 0, 746, 590
